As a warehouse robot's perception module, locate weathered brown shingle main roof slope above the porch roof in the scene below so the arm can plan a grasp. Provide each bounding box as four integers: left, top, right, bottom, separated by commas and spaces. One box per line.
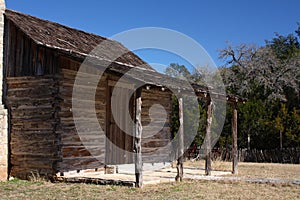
5, 10, 153, 70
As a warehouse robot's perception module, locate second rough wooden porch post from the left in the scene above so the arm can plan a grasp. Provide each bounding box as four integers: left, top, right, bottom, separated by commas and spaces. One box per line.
175, 97, 184, 181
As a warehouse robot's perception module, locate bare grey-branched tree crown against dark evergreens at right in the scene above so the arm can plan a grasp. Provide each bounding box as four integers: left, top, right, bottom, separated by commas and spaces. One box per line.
220, 44, 300, 101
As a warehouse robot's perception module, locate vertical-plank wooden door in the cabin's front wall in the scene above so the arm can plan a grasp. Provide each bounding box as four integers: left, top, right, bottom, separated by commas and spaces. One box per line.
105, 86, 134, 165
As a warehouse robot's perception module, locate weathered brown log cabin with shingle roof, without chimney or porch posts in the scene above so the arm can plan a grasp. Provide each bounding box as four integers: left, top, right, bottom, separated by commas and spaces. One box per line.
4, 10, 178, 178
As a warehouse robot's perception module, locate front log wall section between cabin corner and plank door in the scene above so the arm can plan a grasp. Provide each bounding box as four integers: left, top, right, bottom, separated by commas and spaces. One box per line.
57, 57, 107, 172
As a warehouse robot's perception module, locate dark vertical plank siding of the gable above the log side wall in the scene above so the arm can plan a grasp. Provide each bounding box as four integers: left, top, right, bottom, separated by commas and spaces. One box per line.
4, 20, 59, 77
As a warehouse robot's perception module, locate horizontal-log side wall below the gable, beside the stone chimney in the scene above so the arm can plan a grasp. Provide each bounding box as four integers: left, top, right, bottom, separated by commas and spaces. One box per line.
6, 76, 60, 179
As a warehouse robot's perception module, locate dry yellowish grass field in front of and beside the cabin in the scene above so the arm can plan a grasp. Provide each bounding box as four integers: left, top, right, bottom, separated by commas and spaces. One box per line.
0, 162, 300, 200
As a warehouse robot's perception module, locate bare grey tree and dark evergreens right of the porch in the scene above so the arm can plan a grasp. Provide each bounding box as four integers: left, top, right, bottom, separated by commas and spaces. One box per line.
219, 24, 300, 149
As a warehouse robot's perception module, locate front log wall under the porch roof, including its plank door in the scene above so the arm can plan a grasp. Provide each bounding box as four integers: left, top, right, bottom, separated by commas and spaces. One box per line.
57, 57, 172, 169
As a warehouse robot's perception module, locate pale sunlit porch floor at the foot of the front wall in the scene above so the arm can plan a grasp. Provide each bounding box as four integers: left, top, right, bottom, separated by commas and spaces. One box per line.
56, 164, 231, 187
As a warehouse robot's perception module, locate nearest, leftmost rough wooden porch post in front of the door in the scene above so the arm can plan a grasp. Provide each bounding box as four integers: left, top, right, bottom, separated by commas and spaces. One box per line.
134, 88, 143, 188
